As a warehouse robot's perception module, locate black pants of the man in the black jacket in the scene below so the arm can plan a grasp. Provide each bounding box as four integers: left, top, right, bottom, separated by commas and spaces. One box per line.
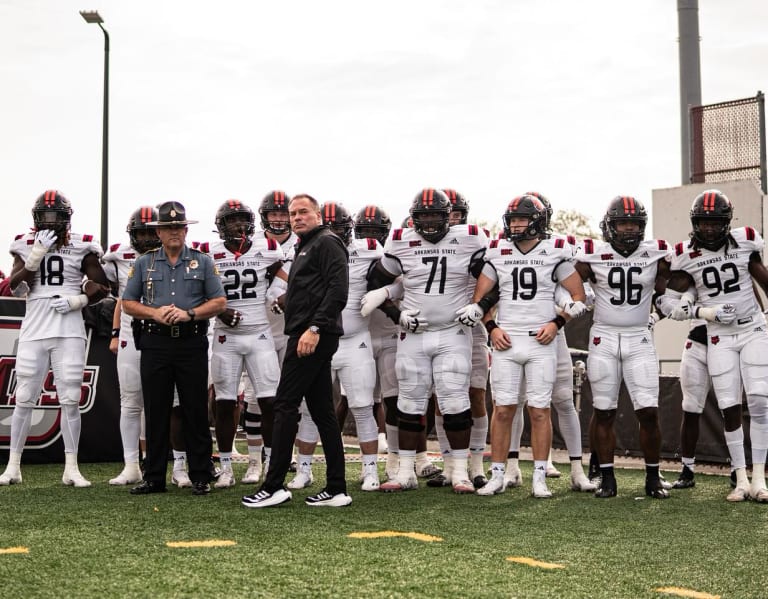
261, 333, 347, 495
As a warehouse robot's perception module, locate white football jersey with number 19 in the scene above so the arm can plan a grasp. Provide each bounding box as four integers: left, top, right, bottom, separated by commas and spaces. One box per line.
483, 238, 575, 335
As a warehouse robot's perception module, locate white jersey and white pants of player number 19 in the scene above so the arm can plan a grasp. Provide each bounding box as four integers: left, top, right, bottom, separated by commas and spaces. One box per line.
483, 239, 575, 408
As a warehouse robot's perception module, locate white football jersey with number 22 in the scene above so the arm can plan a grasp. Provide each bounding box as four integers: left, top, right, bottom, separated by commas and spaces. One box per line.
200, 235, 285, 335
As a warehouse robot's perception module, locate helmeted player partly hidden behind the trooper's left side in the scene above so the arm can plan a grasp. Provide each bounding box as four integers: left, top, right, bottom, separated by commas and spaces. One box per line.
102, 206, 160, 485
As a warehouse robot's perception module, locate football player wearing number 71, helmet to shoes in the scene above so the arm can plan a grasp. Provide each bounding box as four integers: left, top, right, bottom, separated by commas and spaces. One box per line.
370, 189, 488, 493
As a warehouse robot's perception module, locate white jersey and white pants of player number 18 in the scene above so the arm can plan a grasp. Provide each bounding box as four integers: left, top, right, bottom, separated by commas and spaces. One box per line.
10, 233, 102, 405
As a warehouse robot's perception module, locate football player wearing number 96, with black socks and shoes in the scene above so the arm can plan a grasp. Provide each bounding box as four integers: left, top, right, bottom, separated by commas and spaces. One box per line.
576, 196, 669, 499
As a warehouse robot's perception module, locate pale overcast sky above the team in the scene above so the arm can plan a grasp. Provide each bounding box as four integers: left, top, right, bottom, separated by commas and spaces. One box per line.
0, 0, 768, 272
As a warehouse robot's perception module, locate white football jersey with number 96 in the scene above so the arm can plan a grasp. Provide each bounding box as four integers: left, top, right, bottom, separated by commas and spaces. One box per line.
576, 239, 668, 331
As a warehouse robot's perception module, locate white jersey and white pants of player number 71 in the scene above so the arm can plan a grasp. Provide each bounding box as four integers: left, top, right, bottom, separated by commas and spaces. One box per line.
381, 225, 488, 414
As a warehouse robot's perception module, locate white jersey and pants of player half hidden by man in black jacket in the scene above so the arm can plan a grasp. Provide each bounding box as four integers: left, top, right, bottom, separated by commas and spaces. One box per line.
331, 239, 384, 408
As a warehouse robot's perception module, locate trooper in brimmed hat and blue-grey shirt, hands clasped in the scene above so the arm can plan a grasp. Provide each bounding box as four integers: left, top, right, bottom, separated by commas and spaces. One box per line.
122, 202, 226, 495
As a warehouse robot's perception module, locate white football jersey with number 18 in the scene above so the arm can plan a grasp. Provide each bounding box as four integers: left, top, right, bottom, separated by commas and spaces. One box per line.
10, 233, 102, 341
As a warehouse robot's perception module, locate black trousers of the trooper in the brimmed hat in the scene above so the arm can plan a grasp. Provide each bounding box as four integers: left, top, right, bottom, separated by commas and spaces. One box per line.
141, 334, 213, 485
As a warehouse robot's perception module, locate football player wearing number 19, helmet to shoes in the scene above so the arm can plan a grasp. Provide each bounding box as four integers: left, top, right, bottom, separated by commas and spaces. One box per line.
465, 195, 586, 498
